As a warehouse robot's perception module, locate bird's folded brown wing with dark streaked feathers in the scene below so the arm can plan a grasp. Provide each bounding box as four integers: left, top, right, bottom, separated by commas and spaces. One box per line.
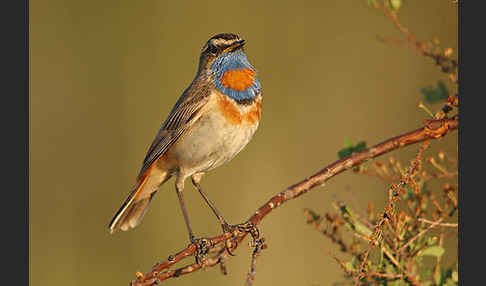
138, 83, 210, 177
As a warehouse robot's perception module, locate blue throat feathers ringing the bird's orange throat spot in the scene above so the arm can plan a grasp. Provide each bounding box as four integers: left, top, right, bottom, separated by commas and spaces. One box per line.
211, 50, 261, 102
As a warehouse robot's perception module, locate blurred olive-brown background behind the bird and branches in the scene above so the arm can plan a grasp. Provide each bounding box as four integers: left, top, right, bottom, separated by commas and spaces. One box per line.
30, 0, 458, 286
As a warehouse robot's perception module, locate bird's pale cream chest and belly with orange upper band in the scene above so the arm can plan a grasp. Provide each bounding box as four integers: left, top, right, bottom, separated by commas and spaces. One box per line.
171, 93, 261, 172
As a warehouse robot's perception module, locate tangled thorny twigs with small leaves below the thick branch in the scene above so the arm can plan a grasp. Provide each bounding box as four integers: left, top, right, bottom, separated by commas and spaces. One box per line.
305, 141, 457, 285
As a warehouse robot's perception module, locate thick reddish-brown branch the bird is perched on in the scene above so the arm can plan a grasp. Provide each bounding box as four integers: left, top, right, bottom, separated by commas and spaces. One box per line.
131, 118, 459, 286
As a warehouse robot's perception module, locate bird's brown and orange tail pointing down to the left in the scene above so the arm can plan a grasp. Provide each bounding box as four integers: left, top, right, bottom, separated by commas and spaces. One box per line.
108, 164, 169, 233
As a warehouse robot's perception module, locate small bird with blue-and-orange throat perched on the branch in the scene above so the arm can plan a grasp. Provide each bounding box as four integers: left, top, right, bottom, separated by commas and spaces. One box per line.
108, 33, 262, 248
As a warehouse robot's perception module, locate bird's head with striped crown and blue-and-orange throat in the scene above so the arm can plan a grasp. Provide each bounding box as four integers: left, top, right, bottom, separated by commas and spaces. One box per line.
199, 33, 260, 101
